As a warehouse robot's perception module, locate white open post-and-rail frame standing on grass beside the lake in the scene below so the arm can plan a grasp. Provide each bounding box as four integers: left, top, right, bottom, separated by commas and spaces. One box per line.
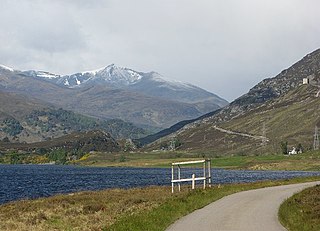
171, 159, 211, 193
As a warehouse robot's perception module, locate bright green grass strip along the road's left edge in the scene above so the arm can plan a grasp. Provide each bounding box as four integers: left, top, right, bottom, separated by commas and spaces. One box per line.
105, 177, 319, 231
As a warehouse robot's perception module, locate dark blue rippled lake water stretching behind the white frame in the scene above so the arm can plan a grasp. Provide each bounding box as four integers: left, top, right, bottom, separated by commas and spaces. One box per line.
0, 165, 320, 204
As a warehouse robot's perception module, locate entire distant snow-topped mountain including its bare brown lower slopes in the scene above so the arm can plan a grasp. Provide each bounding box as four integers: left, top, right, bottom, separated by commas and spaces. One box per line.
0, 65, 227, 130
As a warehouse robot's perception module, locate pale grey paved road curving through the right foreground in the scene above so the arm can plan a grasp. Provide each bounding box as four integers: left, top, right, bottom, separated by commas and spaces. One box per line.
167, 181, 320, 231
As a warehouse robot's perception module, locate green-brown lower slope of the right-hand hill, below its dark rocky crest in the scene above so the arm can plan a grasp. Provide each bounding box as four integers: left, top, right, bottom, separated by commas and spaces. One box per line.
148, 85, 320, 155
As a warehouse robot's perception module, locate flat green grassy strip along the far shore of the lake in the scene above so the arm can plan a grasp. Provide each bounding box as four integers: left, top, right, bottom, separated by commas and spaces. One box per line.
77, 152, 320, 171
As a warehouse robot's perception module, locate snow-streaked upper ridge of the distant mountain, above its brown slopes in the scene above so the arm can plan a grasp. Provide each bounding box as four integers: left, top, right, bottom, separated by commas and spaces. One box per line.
24, 64, 228, 108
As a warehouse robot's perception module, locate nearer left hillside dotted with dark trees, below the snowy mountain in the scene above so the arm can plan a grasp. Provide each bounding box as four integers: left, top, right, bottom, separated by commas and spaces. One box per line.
0, 90, 148, 143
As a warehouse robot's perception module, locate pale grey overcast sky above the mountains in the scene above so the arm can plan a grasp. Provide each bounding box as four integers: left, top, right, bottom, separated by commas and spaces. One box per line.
0, 0, 320, 101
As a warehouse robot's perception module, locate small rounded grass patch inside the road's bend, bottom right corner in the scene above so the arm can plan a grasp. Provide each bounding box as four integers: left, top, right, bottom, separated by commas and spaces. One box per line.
279, 185, 320, 231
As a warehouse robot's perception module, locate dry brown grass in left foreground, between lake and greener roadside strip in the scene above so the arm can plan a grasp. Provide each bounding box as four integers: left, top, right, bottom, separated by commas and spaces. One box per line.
0, 187, 176, 231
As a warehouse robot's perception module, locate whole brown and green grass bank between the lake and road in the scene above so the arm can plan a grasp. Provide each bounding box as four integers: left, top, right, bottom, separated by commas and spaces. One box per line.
0, 177, 320, 231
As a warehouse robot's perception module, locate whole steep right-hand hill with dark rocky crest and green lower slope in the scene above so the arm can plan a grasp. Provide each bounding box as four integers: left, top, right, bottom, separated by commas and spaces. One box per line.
144, 49, 320, 155
